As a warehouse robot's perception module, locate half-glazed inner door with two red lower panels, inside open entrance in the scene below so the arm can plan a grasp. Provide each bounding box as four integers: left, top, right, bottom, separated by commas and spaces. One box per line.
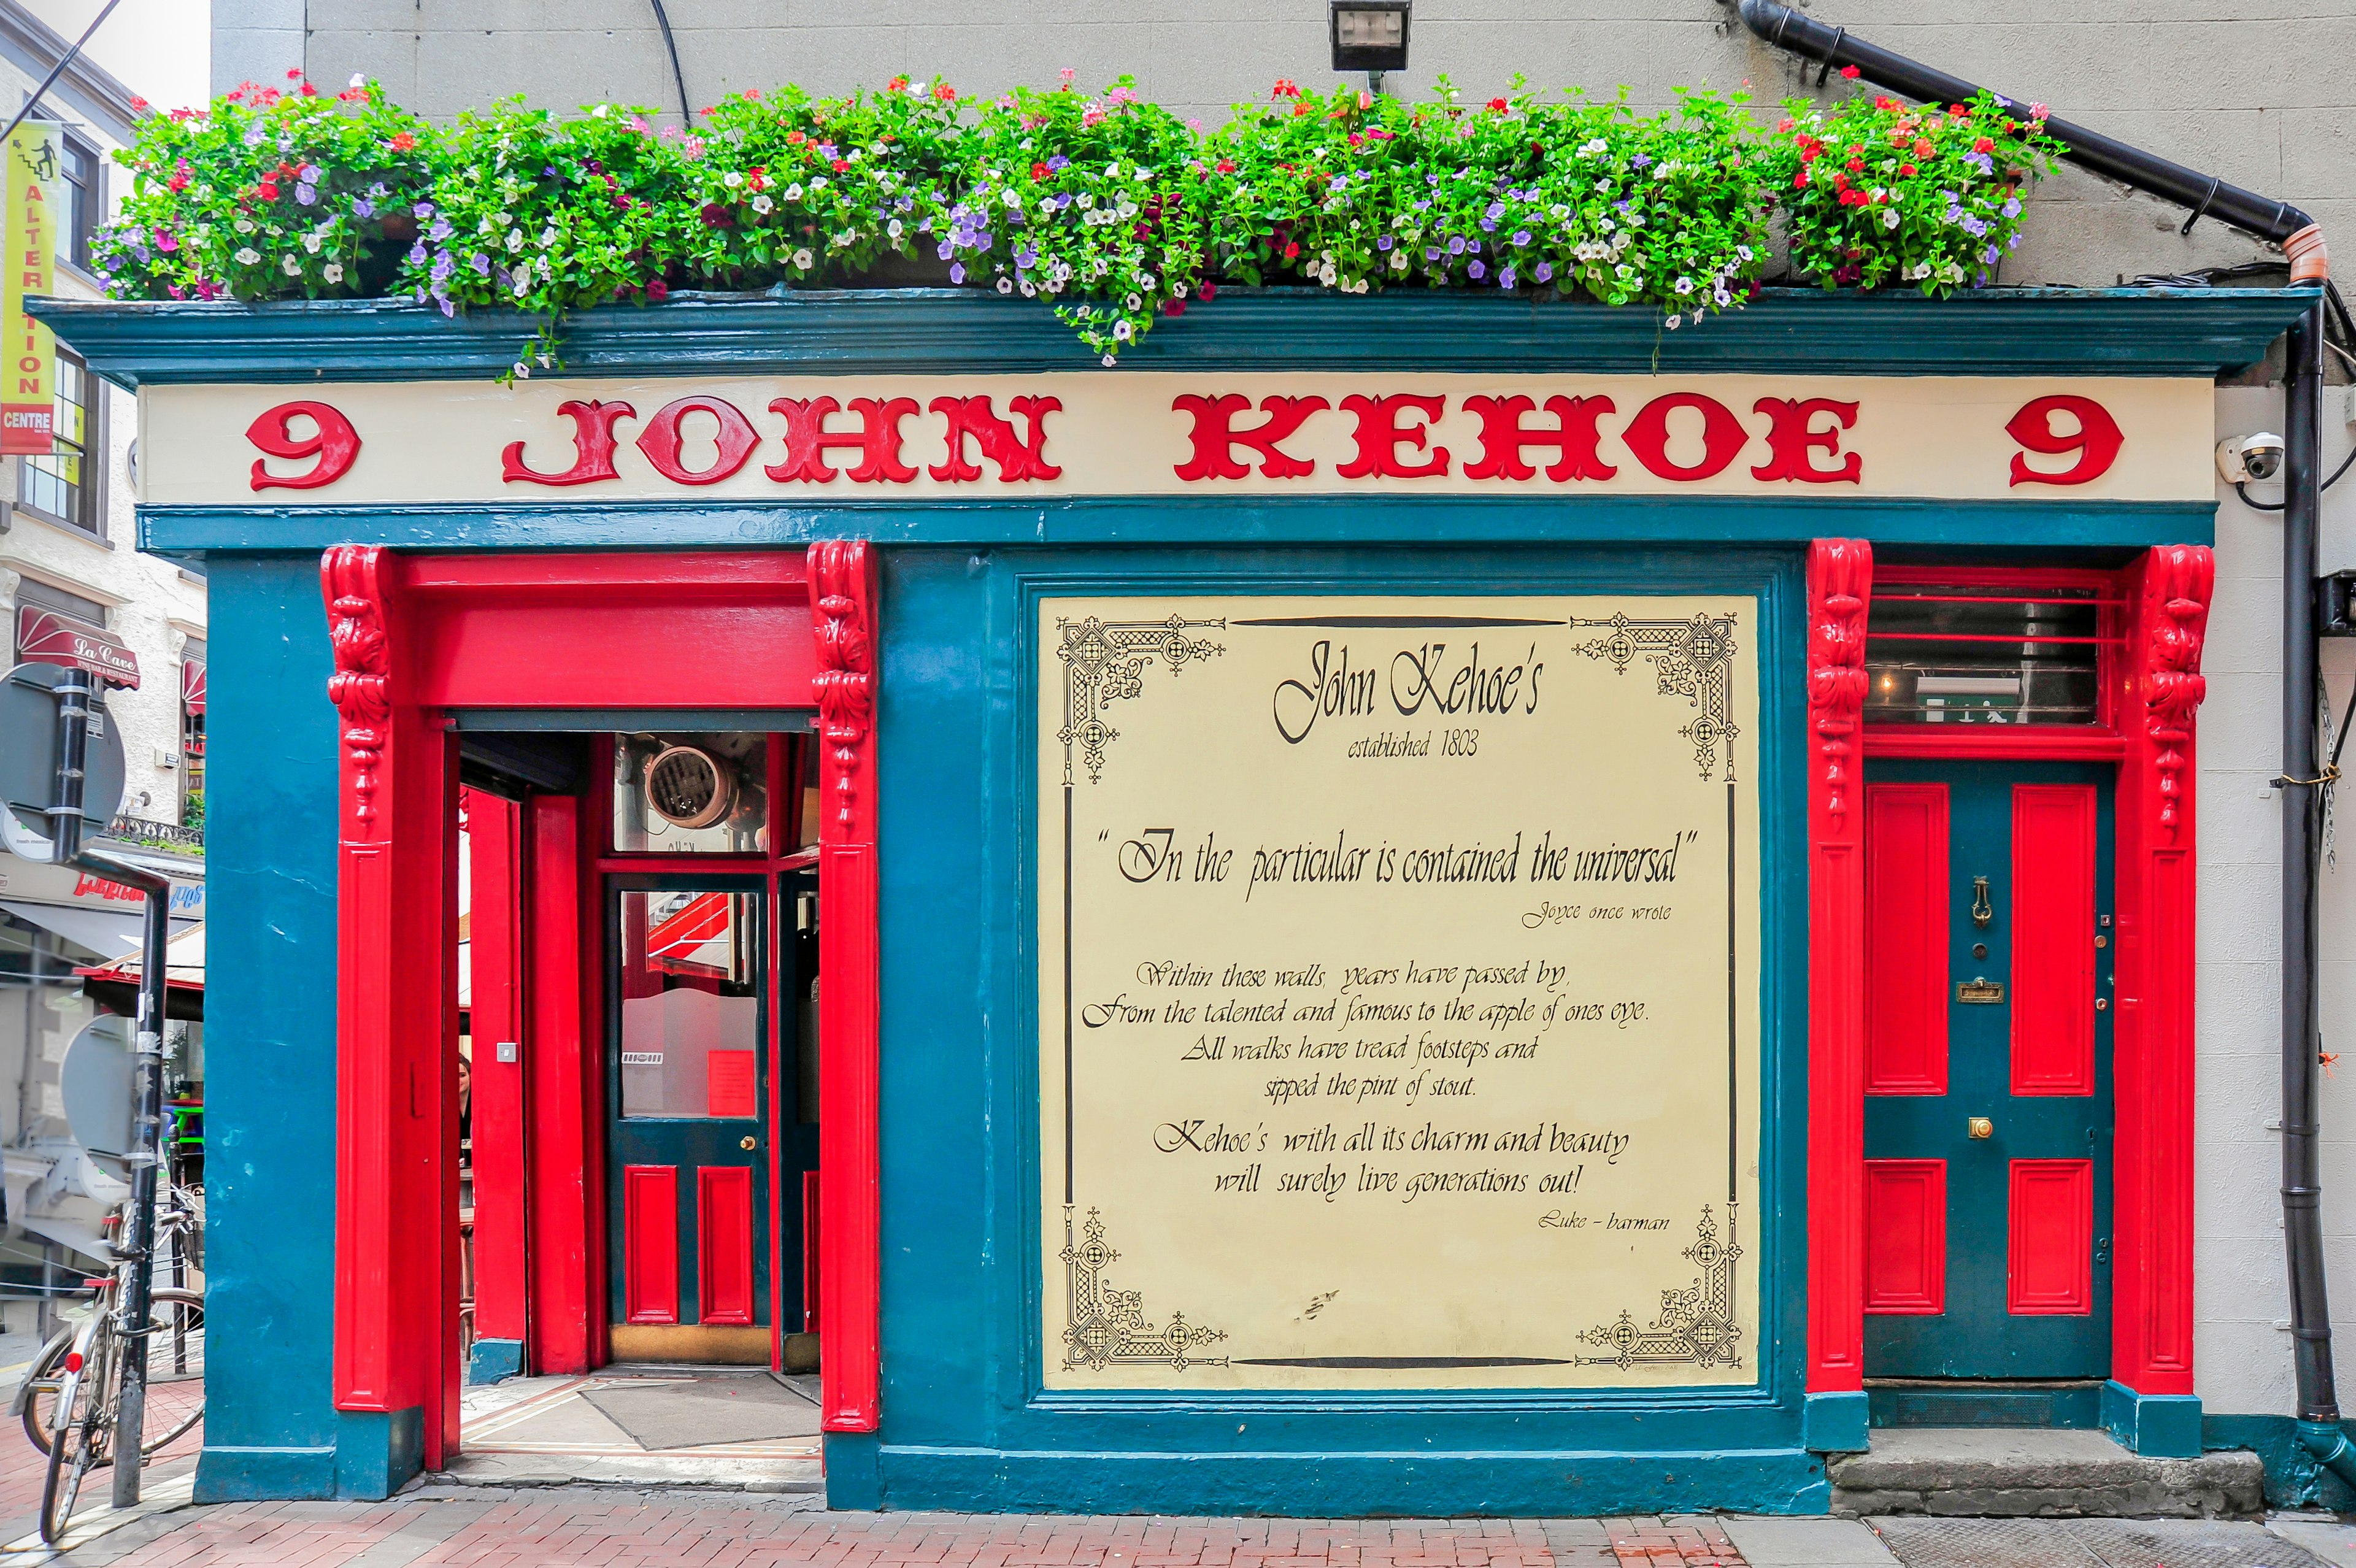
606, 876, 773, 1366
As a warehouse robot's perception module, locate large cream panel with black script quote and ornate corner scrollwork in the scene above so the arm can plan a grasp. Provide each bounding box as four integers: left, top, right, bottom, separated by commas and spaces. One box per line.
1037, 593, 1760, 1389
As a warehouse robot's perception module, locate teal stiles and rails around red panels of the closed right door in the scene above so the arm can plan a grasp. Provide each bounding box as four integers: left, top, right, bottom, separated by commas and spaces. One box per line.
1866, 761, 2115, 1380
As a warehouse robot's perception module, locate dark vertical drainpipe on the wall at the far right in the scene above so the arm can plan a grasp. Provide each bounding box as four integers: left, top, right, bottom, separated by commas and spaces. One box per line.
2278, 299, 2339, 1424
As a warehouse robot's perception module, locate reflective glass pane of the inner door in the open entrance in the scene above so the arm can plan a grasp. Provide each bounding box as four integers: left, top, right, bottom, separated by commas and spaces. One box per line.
622, 890, 761, 1118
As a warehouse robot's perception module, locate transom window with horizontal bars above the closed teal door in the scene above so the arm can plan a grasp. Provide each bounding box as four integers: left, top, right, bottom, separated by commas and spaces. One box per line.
1866, 572, 2111, 725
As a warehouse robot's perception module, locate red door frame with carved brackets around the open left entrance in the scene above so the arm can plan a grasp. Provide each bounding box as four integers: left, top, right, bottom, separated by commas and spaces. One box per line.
320, 542, 879, 1467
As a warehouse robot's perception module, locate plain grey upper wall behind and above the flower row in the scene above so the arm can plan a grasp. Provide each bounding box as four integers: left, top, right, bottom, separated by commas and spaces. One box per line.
212, 0, 2356, 285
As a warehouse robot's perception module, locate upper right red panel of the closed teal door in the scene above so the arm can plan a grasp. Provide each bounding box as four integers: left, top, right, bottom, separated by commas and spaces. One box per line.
2012, 784, 2095, 1095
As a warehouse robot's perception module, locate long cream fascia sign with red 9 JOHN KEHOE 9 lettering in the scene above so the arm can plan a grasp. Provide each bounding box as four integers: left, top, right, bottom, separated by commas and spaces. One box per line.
139, 370, 2215, 506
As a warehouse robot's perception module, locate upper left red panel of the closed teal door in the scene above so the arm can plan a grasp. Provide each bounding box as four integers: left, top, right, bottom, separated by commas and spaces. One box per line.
1866, 784, 1949, 1095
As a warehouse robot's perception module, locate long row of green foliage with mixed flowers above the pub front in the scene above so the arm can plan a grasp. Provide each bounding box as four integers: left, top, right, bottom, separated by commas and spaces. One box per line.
96, 71, 2054, 363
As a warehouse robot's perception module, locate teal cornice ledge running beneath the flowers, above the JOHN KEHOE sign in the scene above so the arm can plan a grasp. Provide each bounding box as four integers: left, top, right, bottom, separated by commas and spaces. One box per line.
28, 287, 2316, 391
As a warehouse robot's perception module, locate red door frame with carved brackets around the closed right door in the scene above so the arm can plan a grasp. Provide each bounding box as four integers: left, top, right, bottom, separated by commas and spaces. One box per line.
1807, 539, 2215, 1394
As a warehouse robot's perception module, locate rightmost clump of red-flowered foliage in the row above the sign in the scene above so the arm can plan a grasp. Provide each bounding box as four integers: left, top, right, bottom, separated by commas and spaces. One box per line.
1767, 80, 2062, 294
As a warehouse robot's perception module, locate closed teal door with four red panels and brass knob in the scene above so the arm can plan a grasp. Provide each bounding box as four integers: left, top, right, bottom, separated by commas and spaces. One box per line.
1863, 761, 2118, 1384
